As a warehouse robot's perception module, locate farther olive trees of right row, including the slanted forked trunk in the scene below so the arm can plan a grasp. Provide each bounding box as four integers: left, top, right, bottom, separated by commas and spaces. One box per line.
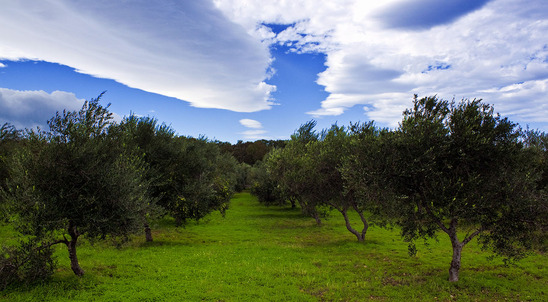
252, 121, 376, 242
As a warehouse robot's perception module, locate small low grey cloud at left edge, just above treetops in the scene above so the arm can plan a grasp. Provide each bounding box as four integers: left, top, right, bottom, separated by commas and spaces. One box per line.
0, 88, 84, 129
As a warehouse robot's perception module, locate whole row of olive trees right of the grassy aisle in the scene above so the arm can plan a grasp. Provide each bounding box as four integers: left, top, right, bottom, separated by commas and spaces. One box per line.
251, 96, 548, 281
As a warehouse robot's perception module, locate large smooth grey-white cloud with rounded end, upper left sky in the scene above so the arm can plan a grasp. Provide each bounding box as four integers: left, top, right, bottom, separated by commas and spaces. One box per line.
0, 0, 275, 112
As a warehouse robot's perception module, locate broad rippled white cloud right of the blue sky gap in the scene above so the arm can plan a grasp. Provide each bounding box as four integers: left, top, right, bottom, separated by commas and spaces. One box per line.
215, 0, 548, 126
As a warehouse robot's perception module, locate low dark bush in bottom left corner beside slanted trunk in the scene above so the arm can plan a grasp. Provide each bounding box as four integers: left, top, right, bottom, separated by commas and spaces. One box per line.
0, 239, 57, 290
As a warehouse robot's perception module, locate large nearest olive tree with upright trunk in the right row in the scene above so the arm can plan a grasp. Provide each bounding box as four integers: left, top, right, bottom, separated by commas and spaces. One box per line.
383, 96, 546, 281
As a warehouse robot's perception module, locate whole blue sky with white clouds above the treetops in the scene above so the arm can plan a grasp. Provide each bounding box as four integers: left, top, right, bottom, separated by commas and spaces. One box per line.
0, 0, 548, 143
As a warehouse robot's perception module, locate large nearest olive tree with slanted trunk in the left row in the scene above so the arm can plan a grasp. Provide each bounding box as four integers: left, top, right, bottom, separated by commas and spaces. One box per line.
4, 94, 148, 276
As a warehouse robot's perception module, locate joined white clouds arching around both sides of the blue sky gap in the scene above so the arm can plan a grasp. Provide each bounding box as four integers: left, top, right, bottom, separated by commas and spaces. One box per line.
4, 0, 548, 131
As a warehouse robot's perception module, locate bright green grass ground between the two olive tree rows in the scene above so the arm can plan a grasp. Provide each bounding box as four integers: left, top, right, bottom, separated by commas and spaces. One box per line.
0, 193, 548, 301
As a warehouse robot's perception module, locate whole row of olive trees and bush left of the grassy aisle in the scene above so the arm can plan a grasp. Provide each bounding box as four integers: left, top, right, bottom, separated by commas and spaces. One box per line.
0, 94, 239, 288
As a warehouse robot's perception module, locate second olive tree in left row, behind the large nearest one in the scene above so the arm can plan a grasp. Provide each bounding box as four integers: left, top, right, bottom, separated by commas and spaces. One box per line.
115, 115, 237, 230
